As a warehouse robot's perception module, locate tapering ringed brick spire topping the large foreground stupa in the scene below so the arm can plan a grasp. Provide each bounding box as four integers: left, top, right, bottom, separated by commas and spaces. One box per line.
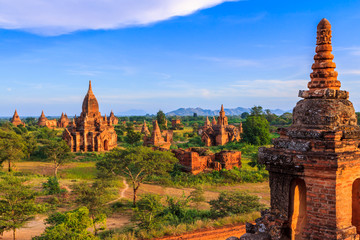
308, 18, 341, 91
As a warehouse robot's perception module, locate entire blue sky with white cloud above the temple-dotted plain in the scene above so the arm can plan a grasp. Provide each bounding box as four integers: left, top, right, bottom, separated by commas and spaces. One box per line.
0, 0, 360, 116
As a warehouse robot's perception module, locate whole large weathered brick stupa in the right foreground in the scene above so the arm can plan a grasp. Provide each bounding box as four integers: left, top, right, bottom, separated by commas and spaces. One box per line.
240, 19, 360, 240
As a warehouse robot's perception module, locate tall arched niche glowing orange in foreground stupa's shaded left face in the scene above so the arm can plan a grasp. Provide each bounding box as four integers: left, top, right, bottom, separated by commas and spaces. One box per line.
289, 179, 306, 240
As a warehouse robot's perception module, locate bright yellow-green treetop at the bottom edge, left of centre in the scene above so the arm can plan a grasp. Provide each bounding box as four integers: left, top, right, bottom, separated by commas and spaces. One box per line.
33, 207, 98, 240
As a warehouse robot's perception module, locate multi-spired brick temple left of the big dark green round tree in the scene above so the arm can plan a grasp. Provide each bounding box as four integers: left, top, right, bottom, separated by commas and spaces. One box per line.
201, 105, 240, 147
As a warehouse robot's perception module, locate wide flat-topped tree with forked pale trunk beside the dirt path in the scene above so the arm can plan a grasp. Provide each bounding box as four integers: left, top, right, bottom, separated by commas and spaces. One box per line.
96, 146, 178, 206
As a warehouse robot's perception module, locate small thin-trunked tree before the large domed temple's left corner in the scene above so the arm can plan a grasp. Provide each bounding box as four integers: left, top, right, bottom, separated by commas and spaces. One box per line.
44, 140, 70, 178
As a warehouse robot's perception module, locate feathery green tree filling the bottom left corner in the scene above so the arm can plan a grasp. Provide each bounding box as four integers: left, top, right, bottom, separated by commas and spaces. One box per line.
0, 174, 43, 240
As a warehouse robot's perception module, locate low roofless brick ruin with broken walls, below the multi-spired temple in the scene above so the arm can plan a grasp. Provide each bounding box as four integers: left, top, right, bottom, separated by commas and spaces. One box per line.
172, 148, 241, 175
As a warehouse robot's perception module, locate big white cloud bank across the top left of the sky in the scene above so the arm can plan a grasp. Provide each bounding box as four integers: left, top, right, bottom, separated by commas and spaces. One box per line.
0, 0, 239, 35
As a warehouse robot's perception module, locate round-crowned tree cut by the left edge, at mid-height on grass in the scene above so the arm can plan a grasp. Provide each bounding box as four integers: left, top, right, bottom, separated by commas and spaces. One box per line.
0, 129, 26, 172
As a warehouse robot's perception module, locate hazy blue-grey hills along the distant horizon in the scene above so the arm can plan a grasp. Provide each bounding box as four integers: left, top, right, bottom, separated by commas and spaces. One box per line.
166, 107, 290, 116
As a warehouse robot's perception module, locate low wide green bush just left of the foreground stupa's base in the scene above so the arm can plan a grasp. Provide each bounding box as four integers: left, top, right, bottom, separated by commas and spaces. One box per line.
209, 191, 264, 217
